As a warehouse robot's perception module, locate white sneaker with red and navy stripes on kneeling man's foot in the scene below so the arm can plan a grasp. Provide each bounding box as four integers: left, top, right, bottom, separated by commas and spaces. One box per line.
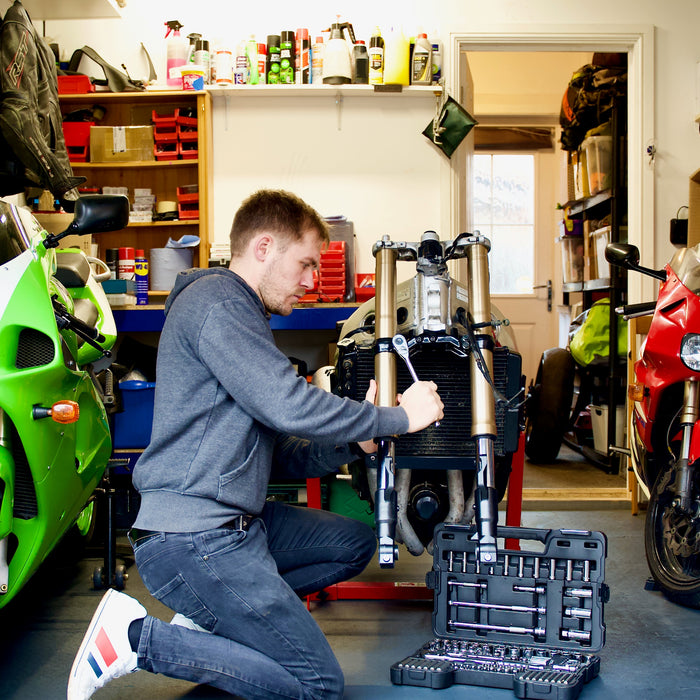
68, 588, 148, 700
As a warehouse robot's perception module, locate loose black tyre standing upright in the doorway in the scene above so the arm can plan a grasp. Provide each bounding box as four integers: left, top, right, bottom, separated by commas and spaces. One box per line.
525, 348, 576, 463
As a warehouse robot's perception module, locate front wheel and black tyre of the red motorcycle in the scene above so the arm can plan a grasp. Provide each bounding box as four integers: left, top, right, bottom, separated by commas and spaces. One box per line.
644, 465, 700, 608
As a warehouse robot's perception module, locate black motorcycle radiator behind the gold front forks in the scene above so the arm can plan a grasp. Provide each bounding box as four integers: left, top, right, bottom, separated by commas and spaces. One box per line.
337, 336, 522, 469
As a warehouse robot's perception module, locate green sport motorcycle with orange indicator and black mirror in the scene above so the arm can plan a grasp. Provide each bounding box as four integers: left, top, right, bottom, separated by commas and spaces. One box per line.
0, 195, 128, 608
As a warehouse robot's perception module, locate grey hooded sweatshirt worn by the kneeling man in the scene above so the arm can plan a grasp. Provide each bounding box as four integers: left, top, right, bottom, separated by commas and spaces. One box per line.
133, 268, 408, 532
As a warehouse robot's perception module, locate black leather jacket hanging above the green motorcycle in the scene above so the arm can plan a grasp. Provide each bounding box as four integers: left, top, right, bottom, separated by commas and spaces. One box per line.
0, 1, 85, 209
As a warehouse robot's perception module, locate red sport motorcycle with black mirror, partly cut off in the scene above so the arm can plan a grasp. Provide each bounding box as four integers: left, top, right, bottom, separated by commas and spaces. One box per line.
605, 243, 700, 608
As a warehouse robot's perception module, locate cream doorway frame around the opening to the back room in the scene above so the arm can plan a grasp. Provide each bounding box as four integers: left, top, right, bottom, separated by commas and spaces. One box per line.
444, 24, 655, 303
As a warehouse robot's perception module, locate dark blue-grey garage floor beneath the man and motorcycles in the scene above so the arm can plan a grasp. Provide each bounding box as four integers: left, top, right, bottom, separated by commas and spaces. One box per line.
0, 508, 700, 700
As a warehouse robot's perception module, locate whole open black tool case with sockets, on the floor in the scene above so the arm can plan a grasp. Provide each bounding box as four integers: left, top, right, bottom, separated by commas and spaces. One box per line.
391, 523, 609, 700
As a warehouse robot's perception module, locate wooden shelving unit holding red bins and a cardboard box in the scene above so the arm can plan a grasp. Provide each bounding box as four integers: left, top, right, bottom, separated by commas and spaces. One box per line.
59, 90, 212, 267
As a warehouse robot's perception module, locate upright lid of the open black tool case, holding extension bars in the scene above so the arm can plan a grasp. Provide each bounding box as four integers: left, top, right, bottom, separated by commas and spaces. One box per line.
426, 523, 609, 653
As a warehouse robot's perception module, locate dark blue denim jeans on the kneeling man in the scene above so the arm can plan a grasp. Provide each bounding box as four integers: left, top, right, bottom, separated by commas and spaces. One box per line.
134, 502, 376, 700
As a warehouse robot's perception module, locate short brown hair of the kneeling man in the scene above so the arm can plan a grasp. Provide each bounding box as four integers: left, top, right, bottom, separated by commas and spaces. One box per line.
230, 190, 329, 258
